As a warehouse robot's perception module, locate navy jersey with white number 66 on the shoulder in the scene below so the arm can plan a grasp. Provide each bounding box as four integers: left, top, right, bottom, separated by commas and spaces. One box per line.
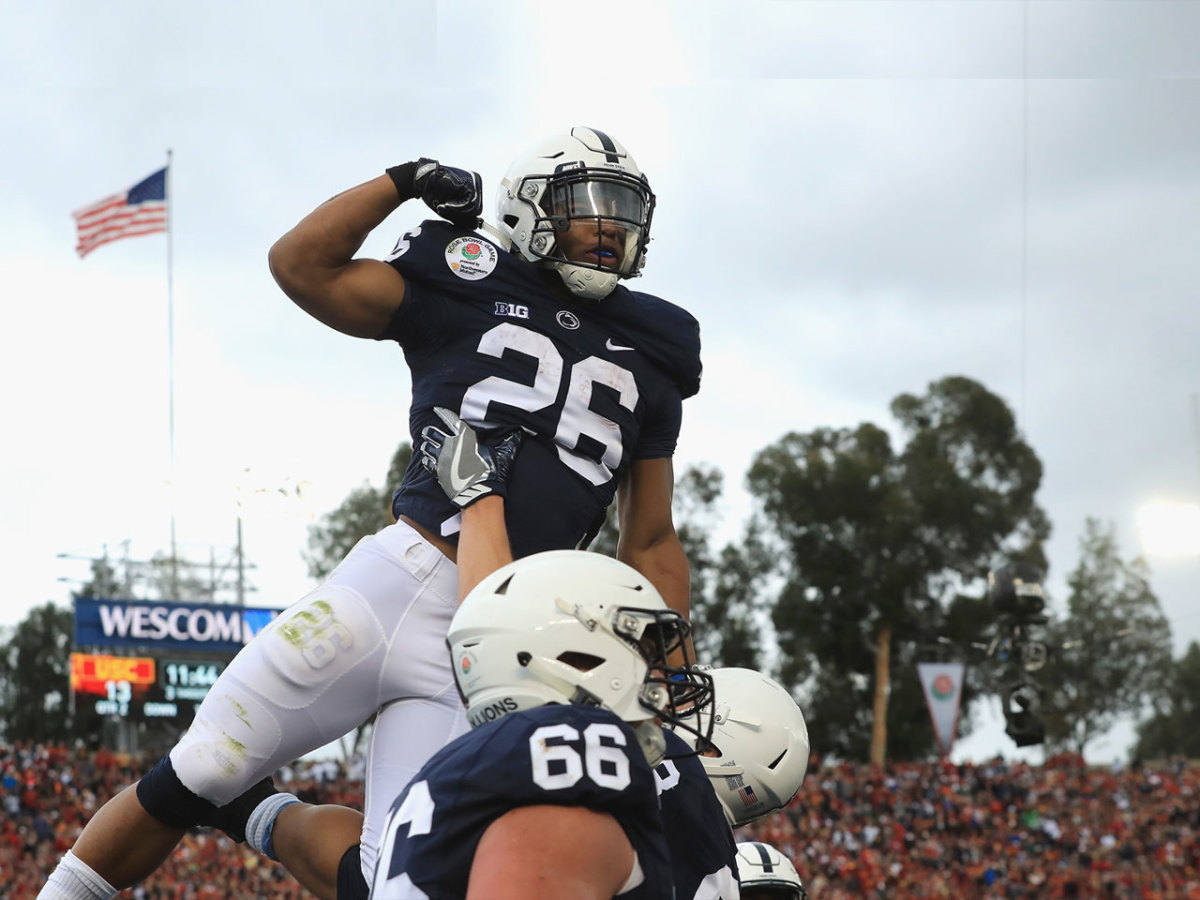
371, 706, 673, 900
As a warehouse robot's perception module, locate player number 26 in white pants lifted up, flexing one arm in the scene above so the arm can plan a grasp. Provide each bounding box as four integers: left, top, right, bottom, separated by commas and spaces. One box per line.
38, 127, 701, 900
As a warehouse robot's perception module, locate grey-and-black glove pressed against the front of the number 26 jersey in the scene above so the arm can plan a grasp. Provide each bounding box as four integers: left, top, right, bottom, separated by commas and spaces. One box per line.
419, 407, 524, 509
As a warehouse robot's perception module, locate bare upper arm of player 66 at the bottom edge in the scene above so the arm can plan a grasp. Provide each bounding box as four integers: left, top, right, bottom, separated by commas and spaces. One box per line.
467, 805, 637, 900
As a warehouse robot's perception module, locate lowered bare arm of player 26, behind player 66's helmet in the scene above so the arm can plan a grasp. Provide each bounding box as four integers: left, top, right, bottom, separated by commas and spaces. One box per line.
617, 457, 691, 618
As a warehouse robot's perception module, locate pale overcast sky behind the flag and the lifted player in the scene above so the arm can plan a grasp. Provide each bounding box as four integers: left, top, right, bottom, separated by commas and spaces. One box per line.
0, 0, 1200, 758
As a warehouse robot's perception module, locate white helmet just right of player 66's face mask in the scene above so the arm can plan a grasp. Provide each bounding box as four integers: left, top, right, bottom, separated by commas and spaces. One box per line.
680, 668, 809, 828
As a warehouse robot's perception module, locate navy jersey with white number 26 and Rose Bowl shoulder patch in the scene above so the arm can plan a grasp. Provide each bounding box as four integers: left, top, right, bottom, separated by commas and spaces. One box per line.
380, 221, 701, 557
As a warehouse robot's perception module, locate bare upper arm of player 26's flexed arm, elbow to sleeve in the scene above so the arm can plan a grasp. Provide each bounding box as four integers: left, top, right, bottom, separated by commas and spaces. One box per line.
271, 259, 404, 337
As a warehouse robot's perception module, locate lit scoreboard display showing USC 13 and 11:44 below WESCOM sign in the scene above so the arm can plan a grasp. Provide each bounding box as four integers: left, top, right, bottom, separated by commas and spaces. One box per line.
71, 653, 228, 724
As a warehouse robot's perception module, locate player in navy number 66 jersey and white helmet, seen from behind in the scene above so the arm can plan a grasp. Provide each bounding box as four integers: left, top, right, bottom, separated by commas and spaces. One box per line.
371, 549, 712, 900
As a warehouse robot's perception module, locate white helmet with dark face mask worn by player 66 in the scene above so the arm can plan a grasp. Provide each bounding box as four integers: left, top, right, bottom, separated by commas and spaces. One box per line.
446, 550, 712, 766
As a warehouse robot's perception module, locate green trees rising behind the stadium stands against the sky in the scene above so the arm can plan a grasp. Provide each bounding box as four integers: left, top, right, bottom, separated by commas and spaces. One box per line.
0, 377, 1200, 761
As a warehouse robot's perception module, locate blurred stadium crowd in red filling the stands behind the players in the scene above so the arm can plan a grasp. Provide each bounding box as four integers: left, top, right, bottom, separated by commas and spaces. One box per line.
0, 743, 1200, 900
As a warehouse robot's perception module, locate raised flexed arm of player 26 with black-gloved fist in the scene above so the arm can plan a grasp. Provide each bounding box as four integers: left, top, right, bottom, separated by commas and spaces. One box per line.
268, 158, 482, 337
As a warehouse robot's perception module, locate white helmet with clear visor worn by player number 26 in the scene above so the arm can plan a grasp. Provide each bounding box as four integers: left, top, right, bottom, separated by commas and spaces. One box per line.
496, 126, 654, 300
